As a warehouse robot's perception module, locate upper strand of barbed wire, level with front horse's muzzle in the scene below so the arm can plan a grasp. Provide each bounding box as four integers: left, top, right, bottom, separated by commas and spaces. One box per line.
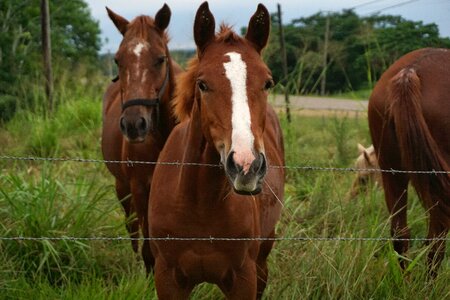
0, 155, 450, 175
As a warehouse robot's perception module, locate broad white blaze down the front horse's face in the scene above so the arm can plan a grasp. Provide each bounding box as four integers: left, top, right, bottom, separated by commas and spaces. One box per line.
223, 52, 255, 174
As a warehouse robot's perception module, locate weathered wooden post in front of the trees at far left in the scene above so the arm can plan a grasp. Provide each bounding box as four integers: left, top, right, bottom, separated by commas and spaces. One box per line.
41, 0, 53, 114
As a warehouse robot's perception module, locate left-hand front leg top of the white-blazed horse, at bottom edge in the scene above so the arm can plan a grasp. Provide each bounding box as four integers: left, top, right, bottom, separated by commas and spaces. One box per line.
155, 259, 194, 300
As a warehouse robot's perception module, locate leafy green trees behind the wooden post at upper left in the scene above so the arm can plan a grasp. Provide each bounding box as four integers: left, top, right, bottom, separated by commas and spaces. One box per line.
0, 0, 100, 121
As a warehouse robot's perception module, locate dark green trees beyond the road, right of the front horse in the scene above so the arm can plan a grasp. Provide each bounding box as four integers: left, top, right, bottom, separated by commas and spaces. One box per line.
264, 10, 450, 94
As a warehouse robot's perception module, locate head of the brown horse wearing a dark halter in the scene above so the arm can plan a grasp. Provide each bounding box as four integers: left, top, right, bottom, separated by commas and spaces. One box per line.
106, 4, 171, 143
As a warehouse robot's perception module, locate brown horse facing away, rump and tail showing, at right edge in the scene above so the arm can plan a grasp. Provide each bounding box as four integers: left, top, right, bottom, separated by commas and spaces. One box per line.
369, 48, 450, 276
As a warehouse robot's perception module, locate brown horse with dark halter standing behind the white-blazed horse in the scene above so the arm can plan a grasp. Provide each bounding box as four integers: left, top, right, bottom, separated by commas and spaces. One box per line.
102, 5, 181, 271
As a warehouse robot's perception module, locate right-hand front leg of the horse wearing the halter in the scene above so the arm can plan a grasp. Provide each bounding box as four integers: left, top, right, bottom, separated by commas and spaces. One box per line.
131, 180, 155, 275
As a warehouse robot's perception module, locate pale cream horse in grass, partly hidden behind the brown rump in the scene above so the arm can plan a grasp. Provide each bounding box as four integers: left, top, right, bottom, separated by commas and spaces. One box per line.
349, 143, 381, 199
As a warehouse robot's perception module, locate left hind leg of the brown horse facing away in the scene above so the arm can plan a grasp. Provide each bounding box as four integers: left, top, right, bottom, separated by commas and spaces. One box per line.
383, 173, 410, 269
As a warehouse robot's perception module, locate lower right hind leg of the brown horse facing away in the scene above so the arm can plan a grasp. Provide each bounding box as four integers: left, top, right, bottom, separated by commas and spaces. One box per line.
427, 214, 449, 279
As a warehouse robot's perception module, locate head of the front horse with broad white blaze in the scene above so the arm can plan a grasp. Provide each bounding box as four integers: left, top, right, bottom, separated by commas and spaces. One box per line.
194, 2, 273, 194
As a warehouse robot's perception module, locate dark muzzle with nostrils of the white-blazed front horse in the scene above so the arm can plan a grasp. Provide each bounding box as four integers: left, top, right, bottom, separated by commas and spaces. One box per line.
225, 151, 267, 195
